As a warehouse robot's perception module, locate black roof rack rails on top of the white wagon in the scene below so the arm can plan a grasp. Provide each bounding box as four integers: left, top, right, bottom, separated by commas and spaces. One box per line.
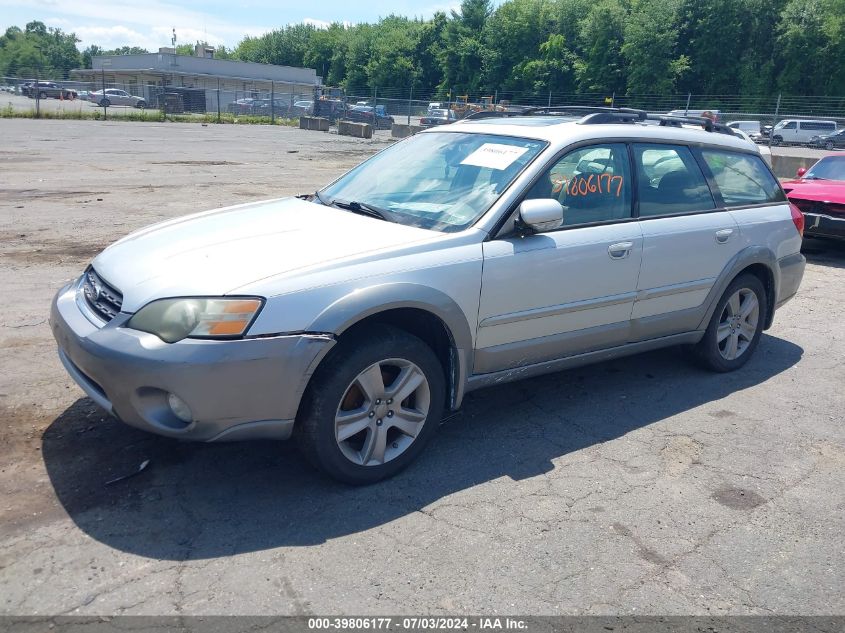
464, 105, 736, 136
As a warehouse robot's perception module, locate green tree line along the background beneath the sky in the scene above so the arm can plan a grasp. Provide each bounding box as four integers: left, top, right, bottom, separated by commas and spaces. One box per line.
0, 0, 845, 98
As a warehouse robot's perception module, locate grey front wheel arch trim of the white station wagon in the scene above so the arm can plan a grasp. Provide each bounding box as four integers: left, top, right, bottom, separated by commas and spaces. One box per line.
309, 283, 473, 410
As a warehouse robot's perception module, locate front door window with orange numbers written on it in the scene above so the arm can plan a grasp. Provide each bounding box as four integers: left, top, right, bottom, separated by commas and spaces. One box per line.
525, 143, 631, 226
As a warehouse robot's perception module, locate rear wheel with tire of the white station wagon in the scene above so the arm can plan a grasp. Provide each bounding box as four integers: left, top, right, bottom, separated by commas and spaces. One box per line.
693, 274, 768, 372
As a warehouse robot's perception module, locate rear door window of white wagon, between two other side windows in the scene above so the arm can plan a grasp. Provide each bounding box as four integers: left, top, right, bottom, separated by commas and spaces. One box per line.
634, 144, 716, 217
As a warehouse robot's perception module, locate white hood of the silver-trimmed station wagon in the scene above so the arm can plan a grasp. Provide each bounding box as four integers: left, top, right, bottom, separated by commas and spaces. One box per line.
93, 198, 443, 312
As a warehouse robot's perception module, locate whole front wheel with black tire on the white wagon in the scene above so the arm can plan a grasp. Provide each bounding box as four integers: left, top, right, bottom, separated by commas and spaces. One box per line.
296, 326, 446, 485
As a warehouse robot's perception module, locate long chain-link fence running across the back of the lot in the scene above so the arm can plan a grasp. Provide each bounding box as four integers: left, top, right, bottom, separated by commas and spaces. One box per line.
0, 76, 845, 144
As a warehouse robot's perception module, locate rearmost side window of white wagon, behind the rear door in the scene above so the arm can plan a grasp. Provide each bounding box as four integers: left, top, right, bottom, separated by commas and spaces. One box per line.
701, 149, 783, 207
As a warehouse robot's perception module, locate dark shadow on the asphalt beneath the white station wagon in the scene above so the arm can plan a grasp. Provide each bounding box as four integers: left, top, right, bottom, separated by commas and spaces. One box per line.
42, 335, 803, 560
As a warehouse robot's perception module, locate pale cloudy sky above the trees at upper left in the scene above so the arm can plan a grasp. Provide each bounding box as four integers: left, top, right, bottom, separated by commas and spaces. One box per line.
0, 0, 460, 51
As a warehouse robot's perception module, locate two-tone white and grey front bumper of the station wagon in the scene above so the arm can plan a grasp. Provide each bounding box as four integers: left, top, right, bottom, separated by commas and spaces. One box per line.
50, 282, 335, 441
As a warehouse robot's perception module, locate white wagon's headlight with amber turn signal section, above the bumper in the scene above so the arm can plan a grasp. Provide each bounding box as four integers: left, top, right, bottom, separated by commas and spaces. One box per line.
126, 297, 263, 343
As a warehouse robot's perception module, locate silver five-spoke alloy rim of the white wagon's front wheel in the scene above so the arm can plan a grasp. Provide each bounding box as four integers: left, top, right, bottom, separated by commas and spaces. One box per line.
335, 358, 431, 466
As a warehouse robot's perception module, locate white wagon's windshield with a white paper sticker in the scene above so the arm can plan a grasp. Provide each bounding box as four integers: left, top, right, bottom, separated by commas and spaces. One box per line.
320, 132, 546, 232
